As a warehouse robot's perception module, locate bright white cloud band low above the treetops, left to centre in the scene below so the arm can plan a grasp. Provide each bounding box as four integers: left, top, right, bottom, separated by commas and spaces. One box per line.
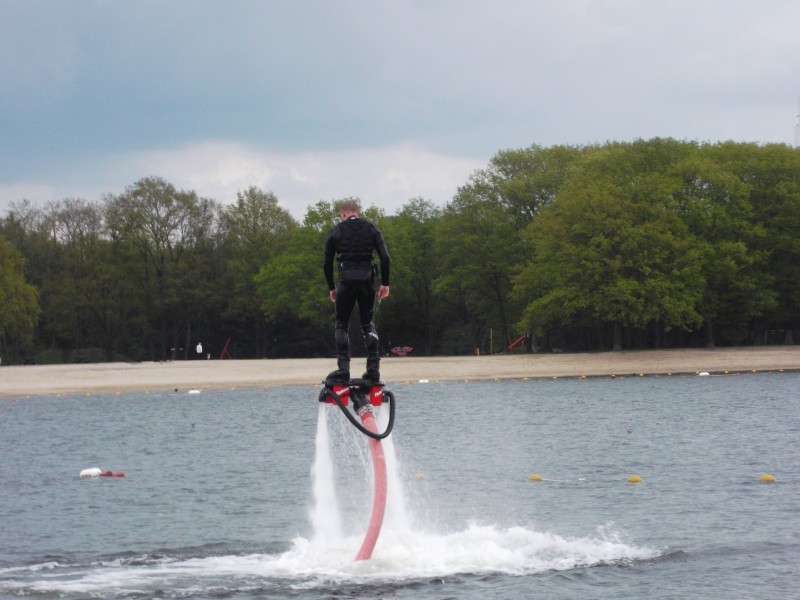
0, 141, 490, 219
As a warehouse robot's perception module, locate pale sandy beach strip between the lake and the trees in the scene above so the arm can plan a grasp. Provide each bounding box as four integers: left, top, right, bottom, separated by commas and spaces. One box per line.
0, 346, 800, 396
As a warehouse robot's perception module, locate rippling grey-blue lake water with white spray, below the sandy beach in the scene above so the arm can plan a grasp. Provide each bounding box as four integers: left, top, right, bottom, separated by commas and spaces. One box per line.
0, 373, 800, 599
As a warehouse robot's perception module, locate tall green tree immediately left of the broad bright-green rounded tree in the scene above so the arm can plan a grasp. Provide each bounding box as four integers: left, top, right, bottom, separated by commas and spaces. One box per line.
433, 145, 584, 349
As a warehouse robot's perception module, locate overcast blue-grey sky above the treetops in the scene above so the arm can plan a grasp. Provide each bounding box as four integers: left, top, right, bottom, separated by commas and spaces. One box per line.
0, 0, 800, 218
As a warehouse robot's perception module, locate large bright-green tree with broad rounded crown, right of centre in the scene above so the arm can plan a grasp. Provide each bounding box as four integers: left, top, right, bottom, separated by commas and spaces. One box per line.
515, 145, 703, 349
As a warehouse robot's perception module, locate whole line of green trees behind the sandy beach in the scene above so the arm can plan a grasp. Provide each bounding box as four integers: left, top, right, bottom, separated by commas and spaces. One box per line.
0, 138, 800, 363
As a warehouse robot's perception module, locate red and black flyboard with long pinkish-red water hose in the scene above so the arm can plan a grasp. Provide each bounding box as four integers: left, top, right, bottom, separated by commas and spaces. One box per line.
319, 379, 395, 560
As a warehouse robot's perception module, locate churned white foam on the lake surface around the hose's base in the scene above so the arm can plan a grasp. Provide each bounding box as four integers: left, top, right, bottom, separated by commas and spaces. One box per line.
10, 524, 660, 596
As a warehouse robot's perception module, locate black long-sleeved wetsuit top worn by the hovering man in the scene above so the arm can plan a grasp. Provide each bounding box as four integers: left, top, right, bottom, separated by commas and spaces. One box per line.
322, 217, 390, 290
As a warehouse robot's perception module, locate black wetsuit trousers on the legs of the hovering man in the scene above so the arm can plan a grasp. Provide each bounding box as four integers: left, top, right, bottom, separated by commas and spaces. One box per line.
335, 281, 380, 373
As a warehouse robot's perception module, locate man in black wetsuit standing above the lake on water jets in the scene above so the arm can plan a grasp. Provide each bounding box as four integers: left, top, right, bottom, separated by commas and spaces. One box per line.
322, 198, 390, 383
